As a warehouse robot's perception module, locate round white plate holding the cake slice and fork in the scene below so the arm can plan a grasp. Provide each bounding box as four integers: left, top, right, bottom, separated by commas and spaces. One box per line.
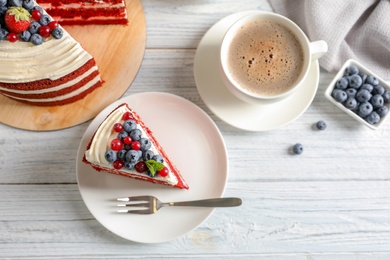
76, 92, 228, 243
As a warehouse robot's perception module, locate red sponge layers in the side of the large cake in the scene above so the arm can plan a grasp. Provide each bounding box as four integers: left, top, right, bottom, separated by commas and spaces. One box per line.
0, 58, 102, 106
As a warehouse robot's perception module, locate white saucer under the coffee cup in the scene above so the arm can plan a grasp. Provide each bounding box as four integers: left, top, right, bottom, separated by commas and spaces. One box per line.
194, 11, 320, 131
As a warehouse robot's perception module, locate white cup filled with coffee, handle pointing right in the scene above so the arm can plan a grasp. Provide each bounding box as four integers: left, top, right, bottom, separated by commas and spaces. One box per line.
219, 11, 328, 104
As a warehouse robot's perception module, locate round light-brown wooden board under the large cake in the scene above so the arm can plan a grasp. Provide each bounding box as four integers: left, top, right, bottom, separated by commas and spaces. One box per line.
0, 0, 146, 131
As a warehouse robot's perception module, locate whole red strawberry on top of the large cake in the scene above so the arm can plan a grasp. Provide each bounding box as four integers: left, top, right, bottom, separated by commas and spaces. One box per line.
4, 7, 31, 33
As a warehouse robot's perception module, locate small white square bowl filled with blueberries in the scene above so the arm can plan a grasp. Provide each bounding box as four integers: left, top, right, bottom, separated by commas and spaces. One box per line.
325, 60, 390, 130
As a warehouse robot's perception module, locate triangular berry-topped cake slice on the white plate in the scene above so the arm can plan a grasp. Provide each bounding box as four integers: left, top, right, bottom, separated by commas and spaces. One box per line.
83, 103, 189, 189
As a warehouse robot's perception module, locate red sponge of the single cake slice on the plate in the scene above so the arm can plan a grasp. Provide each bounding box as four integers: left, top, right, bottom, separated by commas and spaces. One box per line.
83, 103, 189, 189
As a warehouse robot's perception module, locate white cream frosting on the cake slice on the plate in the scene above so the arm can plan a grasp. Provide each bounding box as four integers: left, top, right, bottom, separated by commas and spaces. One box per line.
85, 106, 178, 185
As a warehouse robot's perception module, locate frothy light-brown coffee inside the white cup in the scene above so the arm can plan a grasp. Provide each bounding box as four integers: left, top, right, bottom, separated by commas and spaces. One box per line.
227, 19, 304, 96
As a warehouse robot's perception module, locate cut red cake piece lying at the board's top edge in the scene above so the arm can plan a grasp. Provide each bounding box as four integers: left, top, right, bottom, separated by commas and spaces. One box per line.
38, 0, 127, 25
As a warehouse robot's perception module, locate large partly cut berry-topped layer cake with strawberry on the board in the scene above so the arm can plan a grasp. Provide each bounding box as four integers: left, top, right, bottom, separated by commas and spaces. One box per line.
0, 0, 102, 106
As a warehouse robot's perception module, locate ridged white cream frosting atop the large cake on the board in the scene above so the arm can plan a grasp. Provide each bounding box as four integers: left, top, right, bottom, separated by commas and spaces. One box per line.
0, 1, 92, 83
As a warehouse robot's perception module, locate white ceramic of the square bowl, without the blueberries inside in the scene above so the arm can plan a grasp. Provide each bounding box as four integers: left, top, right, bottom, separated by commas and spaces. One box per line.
325, 59, 390, 130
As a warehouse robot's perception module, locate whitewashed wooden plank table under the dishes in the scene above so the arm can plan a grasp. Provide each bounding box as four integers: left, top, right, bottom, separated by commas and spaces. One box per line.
0, 0, 390, 260
